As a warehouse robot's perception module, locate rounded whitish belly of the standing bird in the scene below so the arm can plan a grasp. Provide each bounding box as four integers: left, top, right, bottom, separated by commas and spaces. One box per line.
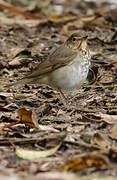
50, 57, 90, 91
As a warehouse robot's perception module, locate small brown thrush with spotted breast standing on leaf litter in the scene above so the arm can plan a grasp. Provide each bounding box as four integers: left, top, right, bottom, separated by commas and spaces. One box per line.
5, 32, 91, 106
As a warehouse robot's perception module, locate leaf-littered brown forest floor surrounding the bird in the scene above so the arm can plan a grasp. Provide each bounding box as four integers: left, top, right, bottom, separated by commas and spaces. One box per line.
0, 0, 117, 180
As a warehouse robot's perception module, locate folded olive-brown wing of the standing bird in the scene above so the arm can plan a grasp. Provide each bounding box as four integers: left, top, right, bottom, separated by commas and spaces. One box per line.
26, 45, 77, 79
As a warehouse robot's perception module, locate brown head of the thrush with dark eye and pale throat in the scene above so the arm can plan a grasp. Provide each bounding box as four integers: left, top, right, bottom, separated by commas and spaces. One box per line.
65, 33, 87, 51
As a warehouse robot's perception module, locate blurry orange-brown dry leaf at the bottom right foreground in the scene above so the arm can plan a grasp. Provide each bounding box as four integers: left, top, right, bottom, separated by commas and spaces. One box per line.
64, 151, 109, 171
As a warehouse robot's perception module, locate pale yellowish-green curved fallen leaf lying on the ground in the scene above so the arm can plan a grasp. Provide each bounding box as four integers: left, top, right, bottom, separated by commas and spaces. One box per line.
16, 143, 61, 160
